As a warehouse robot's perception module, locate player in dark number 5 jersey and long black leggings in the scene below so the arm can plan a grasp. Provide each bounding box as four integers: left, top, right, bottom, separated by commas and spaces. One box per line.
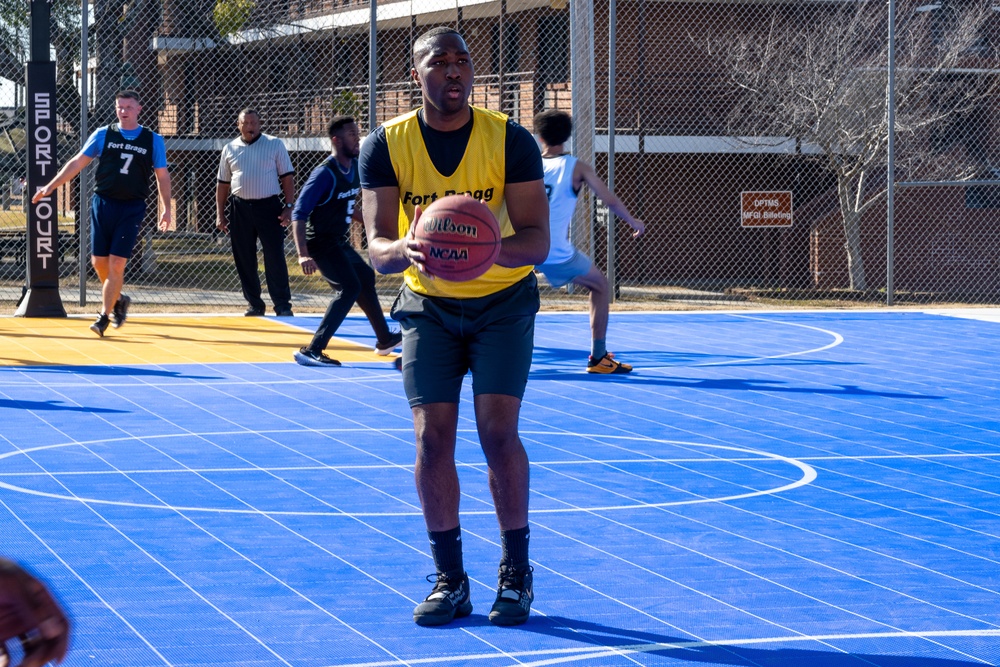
292, 116, 403, 366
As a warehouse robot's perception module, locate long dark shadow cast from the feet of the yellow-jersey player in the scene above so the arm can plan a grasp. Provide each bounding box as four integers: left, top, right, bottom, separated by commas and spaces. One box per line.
520, 616, 982, 667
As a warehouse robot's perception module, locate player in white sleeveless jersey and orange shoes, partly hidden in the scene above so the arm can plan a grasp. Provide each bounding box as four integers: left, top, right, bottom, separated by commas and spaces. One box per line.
534, 109, 646, 375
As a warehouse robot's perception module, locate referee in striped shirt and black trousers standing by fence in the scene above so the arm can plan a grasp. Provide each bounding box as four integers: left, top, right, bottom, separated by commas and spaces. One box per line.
215, 109, 295, 317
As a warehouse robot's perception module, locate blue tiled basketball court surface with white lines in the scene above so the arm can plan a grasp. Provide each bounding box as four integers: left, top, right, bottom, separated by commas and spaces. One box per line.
0, 310, 1000, 667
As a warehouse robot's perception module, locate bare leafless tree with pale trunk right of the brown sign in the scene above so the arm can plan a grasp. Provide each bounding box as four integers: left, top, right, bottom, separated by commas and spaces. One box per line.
708, 0, 1000, 290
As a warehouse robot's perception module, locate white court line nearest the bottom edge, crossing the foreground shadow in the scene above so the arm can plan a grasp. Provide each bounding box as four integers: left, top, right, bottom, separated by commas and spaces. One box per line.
331, 630, 1000, 667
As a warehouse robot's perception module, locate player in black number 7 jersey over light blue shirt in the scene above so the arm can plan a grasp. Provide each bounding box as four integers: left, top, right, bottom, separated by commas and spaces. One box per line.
31, 90, 170, 336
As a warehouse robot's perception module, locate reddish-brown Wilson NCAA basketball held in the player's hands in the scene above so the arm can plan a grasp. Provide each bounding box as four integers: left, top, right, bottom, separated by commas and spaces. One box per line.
414, 195, 500, 282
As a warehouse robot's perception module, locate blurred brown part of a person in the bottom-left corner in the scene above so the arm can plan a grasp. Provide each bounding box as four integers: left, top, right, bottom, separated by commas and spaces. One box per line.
0, 558, 70, 667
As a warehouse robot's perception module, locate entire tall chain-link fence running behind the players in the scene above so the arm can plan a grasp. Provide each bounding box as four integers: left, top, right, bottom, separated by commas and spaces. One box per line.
0, 0, 1000, 312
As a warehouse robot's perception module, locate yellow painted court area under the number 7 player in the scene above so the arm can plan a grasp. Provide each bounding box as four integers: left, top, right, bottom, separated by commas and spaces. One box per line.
0, 315, 391, 366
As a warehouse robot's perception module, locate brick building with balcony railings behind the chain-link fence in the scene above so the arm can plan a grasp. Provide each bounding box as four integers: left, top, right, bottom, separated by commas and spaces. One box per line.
113, 0, 1000, 292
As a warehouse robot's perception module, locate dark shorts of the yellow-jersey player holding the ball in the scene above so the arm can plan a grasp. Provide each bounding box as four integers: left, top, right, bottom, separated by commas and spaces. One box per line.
391, 273, 539, 407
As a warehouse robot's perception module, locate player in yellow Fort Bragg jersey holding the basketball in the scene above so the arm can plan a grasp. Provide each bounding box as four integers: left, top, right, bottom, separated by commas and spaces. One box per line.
360, 27, 549, 625
